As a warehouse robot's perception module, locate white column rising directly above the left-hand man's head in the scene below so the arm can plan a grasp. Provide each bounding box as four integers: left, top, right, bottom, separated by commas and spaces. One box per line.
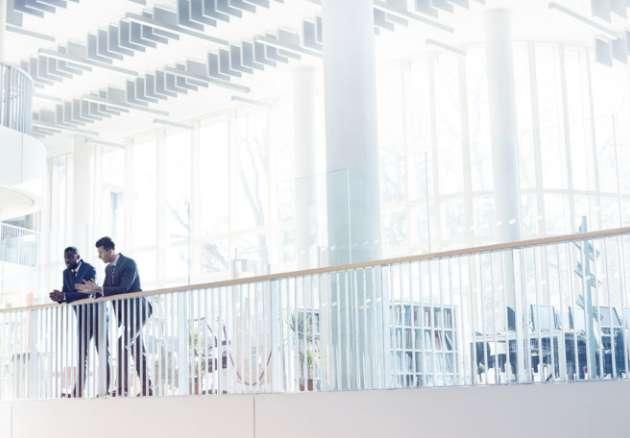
71, 136, 100, 253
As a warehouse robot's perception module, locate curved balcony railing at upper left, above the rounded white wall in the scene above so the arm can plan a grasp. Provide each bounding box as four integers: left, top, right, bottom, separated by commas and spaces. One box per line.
0, 63, 33, 134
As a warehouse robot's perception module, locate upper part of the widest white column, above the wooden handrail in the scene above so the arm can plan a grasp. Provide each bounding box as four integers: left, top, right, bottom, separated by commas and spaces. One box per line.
323, 0, 380, 264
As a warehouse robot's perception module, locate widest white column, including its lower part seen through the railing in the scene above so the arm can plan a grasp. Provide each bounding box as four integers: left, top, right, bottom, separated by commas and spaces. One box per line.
322, 0, 385, 390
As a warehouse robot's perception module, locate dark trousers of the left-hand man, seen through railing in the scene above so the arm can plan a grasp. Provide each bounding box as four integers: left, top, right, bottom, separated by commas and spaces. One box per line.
72, 304, 111, 397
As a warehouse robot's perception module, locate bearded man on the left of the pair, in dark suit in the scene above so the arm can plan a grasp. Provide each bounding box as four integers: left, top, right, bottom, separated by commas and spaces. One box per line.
50, 246, 110, 397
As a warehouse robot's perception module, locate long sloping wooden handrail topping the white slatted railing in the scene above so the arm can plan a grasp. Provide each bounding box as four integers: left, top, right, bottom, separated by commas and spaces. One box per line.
0, 227, 630, 313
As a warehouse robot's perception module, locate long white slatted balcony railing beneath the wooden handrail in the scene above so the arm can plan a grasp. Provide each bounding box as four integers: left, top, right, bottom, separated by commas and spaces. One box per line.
0, 228, 630, 399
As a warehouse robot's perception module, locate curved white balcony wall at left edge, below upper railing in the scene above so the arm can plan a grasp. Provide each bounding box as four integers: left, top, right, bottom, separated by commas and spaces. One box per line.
0, 127, 46, 221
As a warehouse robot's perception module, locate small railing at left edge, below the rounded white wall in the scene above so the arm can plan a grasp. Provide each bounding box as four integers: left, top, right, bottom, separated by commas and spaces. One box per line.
0, 223, 39, 266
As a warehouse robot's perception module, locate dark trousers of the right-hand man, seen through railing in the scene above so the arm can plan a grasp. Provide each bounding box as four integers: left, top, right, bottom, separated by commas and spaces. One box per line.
114, 300, 153, 395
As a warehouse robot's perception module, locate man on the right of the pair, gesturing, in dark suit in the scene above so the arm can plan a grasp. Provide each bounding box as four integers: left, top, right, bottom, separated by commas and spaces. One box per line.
77, 237, 153, 396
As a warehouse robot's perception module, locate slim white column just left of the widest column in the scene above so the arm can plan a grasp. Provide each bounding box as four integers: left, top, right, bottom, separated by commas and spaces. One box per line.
293, 66, 317, 269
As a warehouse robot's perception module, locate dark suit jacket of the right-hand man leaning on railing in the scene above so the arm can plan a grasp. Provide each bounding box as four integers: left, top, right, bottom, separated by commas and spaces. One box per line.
103, 254, 153, 326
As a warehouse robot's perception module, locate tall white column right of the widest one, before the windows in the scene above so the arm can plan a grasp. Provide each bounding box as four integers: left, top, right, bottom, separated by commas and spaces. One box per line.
485, 9, 520, 242
